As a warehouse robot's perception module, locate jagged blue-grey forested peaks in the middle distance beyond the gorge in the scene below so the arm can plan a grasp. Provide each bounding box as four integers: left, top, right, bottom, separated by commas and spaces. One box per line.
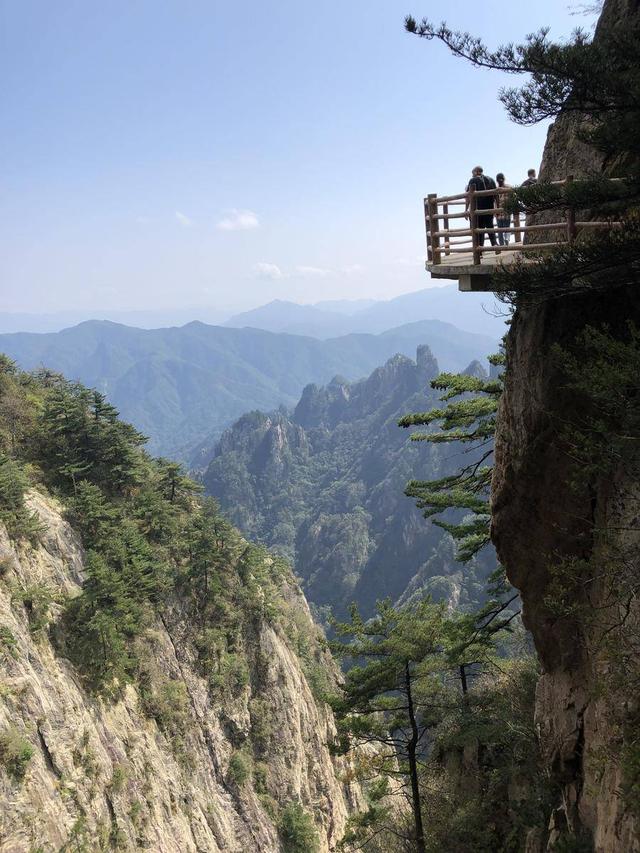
204, 346, 488, 613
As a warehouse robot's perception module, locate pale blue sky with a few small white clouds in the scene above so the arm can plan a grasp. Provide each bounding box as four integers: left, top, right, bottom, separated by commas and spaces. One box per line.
0, 0, 592, 318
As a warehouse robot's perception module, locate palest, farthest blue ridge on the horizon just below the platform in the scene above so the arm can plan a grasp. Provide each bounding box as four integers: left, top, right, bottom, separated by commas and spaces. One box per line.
225, 284, 505, 338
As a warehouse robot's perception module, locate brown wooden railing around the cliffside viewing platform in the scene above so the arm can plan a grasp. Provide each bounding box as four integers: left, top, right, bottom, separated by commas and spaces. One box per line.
424, 175, 618, 265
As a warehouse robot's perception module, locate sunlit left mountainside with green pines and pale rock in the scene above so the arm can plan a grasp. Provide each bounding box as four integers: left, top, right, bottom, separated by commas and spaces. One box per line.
0, 357, 362, 853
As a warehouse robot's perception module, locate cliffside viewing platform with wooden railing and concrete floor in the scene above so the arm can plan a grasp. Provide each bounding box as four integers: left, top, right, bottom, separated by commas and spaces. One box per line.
424, 175, 619, 293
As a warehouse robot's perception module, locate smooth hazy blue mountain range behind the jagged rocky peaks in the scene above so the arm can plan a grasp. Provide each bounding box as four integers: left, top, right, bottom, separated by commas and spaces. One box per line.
0, 321, 495, 459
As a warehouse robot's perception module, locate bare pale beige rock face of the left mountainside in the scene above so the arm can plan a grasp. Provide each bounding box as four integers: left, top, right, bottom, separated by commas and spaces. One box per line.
0, 492, 357, 853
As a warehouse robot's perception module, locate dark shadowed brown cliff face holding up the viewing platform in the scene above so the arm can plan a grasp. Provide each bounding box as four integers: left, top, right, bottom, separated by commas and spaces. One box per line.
492, 0, 640, 853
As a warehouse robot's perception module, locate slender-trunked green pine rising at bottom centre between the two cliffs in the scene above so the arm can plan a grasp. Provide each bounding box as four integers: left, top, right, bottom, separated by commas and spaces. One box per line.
331, 600, 510, 853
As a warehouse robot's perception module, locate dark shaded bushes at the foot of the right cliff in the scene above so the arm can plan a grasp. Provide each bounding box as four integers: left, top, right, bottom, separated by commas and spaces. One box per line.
421, 657, 553, 853
